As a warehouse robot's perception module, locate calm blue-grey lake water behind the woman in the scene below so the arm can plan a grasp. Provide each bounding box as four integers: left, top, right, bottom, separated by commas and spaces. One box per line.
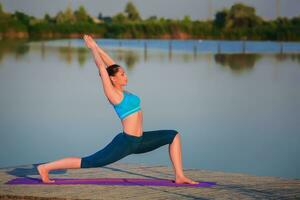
0, 40, 300, 178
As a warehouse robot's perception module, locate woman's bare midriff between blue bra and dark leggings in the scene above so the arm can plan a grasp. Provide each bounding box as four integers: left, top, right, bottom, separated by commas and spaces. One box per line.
122, 110, 143, 137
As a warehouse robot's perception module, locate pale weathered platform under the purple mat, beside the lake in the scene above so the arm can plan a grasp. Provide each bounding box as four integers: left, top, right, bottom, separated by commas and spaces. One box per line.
0, 162, 300, 200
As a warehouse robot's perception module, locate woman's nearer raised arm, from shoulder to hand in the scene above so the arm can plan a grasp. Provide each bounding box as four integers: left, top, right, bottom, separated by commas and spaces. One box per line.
84, 36, 122, 104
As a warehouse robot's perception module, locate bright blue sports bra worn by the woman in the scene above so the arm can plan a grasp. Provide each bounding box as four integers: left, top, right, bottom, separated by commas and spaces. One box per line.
110, 91, 141, 120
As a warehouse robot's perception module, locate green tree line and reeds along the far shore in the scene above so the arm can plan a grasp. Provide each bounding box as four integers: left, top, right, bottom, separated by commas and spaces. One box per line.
0, 2, 300, 41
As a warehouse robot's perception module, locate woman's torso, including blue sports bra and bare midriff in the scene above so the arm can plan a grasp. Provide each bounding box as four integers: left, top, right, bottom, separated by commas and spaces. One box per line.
113, 91, 143, 137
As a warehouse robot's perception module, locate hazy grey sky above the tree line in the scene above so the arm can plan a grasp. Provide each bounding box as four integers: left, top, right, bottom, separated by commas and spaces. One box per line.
0, 0, 300, 20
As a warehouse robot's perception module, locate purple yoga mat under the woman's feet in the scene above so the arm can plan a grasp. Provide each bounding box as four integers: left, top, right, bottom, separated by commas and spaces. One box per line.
5, 177, 216, 187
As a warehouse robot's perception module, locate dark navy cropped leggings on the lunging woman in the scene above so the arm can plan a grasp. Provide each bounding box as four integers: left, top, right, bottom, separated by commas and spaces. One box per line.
80, 130, 178, 168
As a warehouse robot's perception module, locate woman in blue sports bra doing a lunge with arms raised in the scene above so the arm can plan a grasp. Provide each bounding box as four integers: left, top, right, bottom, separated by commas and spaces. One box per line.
37, 35, 198, 184
